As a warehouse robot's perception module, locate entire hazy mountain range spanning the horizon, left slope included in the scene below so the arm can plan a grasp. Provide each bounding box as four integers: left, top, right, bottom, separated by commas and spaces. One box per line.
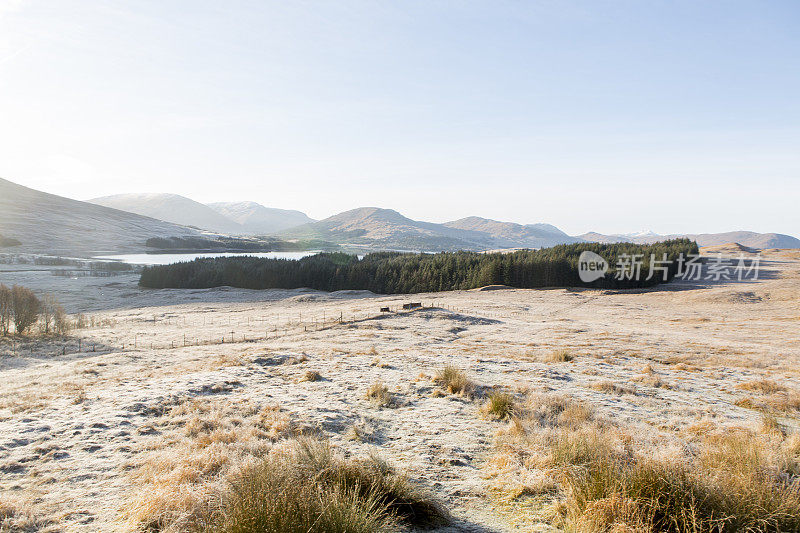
0, 179, 800, 254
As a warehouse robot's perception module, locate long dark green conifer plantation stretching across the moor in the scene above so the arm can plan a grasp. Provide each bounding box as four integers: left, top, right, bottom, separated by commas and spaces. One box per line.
139, 239, 698, 294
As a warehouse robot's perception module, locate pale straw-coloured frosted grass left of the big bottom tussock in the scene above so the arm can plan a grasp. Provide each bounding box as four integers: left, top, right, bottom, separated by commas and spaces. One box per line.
121, 398, 300, 533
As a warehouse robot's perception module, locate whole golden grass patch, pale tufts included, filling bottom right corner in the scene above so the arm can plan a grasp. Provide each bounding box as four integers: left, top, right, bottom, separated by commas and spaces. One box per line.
487, 395, 800, 533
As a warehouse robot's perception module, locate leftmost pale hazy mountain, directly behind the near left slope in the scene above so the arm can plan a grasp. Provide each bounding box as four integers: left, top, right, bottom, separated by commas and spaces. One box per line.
89, 193, 243, 233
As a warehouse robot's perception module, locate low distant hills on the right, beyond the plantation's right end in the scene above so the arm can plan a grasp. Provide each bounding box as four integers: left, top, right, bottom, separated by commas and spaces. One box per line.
578, 231, 800, 250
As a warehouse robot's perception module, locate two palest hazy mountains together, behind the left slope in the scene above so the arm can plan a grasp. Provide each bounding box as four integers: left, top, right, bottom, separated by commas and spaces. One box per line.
89, 193, 314, 235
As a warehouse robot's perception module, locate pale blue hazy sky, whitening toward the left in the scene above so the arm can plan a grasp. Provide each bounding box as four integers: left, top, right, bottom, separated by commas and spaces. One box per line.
0, 0, 800, 235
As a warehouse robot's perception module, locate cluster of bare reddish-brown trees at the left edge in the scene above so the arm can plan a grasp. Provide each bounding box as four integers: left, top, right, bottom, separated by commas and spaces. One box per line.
0, 283, 69, 337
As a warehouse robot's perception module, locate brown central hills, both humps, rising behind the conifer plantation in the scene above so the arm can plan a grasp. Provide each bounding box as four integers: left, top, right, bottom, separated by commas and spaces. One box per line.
281, 207, 579, 252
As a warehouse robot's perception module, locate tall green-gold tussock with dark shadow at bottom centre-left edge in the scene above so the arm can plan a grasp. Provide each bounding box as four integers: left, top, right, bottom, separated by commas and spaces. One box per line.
212, 438, 449, 533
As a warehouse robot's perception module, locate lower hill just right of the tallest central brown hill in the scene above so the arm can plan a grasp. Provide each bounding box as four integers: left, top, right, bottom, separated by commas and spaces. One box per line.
444, 217, 580, 248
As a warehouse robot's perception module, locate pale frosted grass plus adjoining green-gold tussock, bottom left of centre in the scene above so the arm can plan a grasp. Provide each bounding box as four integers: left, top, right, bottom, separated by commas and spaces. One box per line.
127, 400, 449, 533
